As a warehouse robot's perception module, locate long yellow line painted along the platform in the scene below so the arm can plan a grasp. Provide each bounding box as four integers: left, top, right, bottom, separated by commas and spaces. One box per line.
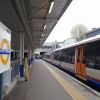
42, 61, 88, 100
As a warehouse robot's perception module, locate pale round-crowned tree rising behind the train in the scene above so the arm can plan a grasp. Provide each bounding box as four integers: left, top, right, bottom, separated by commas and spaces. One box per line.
71, 24, 88, 41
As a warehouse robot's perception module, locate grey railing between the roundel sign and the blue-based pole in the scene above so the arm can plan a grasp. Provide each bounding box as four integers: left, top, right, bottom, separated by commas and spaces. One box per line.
3, 60, 20, 96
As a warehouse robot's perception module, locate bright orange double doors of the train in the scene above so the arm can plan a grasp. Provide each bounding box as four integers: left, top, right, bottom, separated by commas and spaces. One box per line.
75, 47, 86, 79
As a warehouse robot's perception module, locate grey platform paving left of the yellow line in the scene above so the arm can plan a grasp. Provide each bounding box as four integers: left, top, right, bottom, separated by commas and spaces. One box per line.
7, 60, 73, 100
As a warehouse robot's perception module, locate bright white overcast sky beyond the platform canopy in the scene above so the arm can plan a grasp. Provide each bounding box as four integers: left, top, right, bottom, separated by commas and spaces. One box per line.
46, 0, 100, 42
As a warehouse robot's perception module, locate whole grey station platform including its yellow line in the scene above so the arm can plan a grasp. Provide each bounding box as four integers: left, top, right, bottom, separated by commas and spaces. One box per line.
5, 59, 100, 100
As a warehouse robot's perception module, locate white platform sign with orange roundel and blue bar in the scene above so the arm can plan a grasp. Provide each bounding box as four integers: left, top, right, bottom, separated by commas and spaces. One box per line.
0, 22, 11, 73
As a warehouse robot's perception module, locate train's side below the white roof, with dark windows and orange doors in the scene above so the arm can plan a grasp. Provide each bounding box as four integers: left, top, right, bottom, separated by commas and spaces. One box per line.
43, 41, 100, 88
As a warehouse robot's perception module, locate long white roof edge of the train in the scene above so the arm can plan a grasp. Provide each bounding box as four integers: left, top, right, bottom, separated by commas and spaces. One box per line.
45, 34, 100, 53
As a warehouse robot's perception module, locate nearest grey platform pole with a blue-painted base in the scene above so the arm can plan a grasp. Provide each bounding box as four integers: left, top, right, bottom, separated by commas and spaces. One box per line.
20, 33, 24, 77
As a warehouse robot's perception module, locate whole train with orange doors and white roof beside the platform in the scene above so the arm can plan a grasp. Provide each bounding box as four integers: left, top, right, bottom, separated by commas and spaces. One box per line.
43, 34, 100, 89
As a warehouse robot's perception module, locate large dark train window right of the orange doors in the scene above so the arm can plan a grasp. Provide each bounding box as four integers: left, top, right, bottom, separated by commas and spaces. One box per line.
85, 44, 100, 70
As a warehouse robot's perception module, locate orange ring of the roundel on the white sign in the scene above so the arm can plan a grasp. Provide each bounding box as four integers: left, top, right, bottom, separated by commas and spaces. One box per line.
0, 39, 10, 65
